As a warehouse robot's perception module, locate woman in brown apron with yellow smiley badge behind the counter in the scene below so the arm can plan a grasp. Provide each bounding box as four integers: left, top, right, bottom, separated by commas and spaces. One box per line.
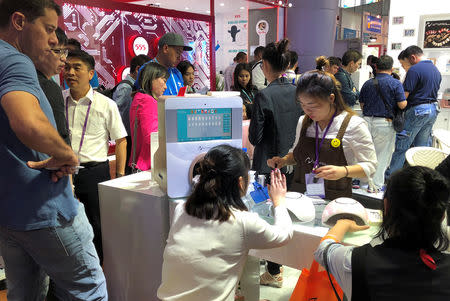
267, 70, 377, 200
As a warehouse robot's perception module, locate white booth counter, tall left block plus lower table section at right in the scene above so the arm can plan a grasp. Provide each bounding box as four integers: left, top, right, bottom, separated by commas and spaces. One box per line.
99, 172, 377, 301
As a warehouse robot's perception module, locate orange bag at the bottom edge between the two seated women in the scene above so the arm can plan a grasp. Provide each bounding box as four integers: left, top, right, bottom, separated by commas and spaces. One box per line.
289, 244, 347, 301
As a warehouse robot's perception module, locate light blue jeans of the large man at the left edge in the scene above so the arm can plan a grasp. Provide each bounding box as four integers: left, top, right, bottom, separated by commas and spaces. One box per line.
0, 203, 108, 301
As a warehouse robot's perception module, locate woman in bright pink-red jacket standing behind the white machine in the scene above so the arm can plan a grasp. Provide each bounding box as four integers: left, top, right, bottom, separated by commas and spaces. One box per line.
128, 62, 169, 170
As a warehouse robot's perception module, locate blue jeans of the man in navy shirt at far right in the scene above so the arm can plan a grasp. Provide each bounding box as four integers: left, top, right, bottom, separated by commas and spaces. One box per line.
386, 103, 438, 177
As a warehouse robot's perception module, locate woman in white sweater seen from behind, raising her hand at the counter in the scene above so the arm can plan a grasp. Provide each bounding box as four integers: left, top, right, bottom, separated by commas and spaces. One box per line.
158, 145, 293, 301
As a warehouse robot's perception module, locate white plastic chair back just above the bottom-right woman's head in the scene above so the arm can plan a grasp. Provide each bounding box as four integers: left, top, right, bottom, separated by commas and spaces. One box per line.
406, 146, 448, 169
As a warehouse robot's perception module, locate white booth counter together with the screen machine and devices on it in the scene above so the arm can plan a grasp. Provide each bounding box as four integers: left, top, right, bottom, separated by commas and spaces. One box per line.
99, 92, 381, 301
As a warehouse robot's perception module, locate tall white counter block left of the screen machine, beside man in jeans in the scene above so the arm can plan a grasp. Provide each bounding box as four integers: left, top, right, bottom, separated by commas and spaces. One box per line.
99, 172, 169, 301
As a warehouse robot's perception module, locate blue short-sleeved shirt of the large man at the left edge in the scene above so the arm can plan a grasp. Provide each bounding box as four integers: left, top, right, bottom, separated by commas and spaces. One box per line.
0, 40, 78, 231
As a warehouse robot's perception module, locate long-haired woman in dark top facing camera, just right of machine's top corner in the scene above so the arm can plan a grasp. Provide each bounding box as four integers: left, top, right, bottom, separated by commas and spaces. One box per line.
231, 63, 258, 120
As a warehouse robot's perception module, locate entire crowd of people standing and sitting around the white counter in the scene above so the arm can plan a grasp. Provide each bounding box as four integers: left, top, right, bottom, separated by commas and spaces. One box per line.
0, 0, 450, 300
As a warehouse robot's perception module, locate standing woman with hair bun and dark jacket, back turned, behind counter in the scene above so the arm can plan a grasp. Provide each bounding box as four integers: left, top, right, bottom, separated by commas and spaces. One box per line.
248, 39, 302, 287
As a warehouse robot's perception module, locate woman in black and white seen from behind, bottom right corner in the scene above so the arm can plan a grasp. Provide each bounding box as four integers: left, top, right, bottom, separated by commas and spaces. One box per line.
314, 166, 450, 301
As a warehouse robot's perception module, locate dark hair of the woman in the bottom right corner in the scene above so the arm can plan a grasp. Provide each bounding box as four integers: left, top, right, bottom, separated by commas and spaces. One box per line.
377, 166, 450, 251
